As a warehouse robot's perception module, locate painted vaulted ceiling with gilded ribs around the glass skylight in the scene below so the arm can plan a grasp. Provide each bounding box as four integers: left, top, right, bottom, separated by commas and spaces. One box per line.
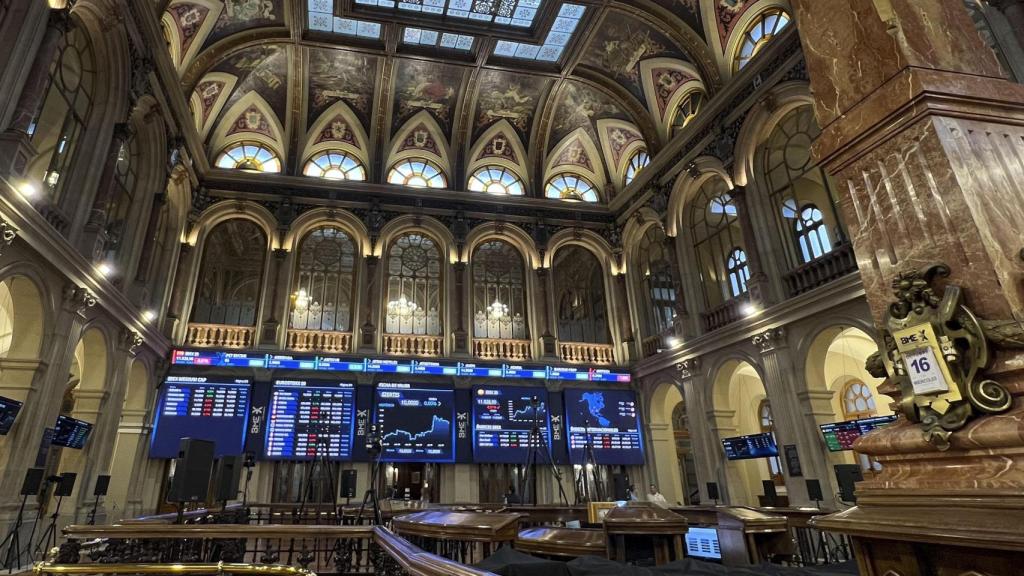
162, 0, 779, 201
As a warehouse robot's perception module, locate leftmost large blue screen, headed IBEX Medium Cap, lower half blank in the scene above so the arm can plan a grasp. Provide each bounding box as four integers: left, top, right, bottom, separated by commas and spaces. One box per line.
150, 376, 250, 458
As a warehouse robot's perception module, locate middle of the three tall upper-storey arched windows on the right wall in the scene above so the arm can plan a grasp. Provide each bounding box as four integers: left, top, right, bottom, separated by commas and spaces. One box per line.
689, 178, 750, 310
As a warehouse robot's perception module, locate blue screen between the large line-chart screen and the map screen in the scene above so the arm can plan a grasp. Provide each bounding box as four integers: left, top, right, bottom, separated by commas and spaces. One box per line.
473, 386, 551, 464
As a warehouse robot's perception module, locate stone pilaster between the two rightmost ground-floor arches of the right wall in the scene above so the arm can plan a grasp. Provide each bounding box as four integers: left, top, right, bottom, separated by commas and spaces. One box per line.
752, 328, 831, 506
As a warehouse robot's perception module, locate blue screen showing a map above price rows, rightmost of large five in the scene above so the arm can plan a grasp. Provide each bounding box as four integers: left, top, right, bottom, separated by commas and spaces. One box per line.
565, 388, 643, 466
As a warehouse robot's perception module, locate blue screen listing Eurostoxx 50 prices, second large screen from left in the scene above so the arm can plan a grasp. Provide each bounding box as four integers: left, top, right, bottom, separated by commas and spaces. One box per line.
263, 380, 355, 460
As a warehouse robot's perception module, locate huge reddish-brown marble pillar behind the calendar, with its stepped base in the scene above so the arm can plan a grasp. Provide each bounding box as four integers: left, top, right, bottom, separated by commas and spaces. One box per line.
792, 0, 1024, 557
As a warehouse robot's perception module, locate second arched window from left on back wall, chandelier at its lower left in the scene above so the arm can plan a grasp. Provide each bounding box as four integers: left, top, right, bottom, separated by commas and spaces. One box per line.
289, 227, 355, 332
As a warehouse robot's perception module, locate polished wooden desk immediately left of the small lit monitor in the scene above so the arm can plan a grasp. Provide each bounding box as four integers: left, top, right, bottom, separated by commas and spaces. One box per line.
604, 503, 686, 566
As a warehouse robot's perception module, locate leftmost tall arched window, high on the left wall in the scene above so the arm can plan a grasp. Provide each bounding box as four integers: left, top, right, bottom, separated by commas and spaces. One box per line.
28, 26, 96, 202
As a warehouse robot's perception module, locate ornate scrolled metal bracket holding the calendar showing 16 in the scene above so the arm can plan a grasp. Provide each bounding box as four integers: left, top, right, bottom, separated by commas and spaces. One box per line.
866, 263, 1020, 450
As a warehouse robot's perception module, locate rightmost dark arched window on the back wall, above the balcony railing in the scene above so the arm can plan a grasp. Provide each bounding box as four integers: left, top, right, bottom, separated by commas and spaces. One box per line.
552, 246, 611, 344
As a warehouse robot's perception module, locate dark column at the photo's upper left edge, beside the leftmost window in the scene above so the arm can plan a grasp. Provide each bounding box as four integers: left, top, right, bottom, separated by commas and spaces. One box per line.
0, 8, 71, 176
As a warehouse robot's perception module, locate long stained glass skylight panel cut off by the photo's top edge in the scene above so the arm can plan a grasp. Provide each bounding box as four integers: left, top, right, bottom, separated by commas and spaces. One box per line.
355, 0, 545, 28
